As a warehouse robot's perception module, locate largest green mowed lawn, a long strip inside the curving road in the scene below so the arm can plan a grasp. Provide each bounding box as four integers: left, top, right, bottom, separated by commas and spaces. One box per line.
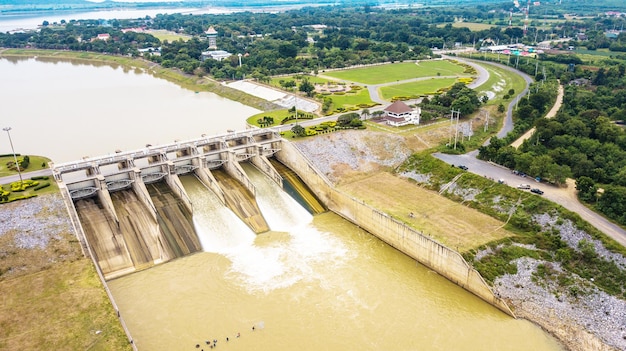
323, 60, 466, 84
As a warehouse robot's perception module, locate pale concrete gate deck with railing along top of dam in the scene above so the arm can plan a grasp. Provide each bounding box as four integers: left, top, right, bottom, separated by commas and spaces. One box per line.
52, 129, 282, 191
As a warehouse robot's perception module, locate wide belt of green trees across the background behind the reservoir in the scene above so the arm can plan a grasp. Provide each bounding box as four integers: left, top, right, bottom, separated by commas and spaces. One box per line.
0, 3, 626, 80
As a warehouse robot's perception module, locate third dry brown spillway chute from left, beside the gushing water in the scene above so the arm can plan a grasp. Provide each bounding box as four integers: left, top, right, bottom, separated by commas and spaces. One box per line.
146, 182, 201, 258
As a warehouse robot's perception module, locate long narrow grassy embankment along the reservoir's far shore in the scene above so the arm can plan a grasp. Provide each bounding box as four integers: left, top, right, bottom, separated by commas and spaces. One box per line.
0, 49, 278, 111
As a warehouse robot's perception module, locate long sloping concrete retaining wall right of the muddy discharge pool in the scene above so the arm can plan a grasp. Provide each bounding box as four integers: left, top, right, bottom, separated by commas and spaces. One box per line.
276, 141, 515, 317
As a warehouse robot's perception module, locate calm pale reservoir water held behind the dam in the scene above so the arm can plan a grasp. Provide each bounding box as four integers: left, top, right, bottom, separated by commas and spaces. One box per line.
0, 57, 259, 163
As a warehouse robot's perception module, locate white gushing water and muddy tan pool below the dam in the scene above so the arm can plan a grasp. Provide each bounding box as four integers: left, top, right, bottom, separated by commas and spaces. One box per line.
109, 169, 561, 351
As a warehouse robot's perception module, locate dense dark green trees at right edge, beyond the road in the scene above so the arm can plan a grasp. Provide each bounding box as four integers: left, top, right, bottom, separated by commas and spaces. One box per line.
480, 55, 626, 224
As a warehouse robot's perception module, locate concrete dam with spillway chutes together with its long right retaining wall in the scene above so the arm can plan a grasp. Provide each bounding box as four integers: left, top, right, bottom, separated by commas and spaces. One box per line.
52, 129, 513, 315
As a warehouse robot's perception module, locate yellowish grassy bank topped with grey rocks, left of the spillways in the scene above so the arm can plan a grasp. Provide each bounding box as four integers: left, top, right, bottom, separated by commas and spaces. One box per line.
0, 188, 131, 351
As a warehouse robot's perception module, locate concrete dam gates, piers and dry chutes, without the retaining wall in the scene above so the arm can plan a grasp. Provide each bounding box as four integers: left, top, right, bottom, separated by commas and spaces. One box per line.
52, 131, 282, 280
